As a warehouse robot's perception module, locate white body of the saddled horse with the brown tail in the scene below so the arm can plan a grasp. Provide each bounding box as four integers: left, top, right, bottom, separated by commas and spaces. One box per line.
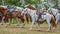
22, 8, 56, 31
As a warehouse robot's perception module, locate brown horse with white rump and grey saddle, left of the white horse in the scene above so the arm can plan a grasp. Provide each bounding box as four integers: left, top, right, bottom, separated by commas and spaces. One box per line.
6, 6, 25, 27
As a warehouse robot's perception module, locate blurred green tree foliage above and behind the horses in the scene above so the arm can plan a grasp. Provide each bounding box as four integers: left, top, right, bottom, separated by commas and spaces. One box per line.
0, 0, 60, 8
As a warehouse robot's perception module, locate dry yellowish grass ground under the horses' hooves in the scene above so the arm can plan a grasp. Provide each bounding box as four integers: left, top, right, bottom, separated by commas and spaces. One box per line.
0, 24, 60, 34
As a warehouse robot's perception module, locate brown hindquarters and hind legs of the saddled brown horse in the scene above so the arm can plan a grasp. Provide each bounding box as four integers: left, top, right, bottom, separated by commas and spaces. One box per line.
12, 10, 25, 27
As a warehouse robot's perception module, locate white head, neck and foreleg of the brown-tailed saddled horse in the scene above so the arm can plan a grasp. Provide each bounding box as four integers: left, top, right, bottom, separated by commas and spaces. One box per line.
22, 8, 39, 30
